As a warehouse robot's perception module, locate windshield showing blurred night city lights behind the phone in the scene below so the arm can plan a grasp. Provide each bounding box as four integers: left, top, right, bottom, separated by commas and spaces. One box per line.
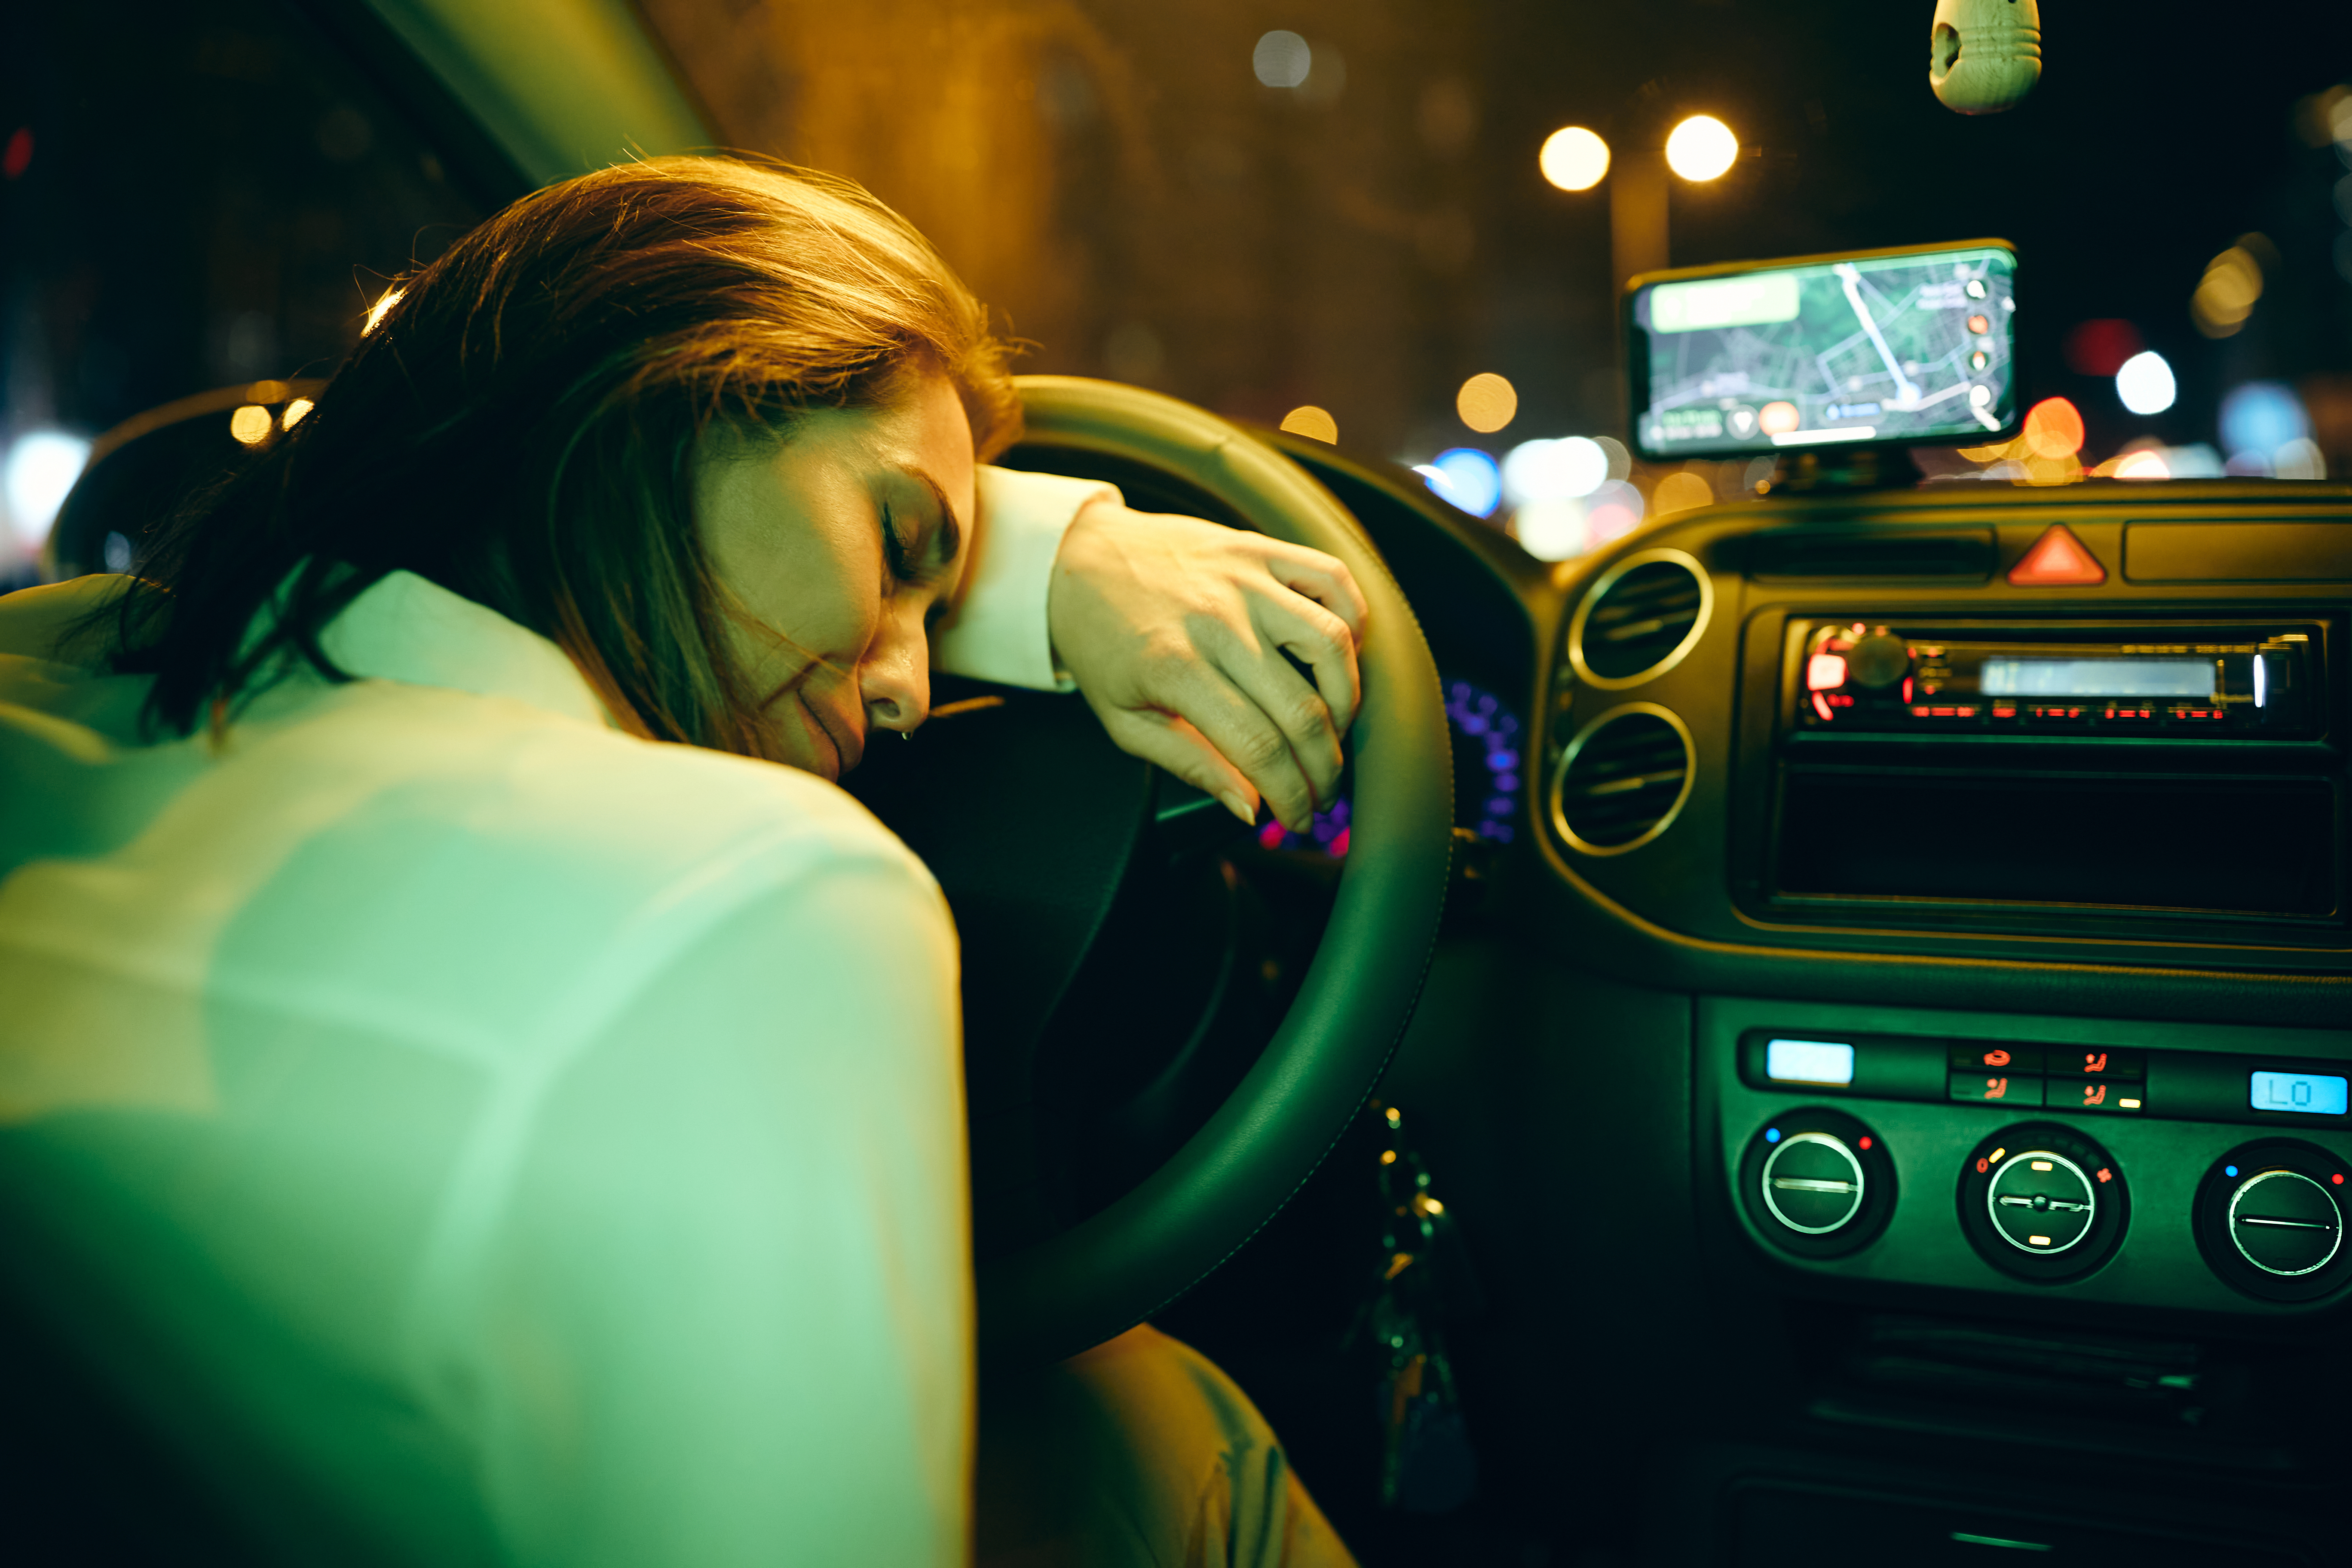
644, 0, 2352, 552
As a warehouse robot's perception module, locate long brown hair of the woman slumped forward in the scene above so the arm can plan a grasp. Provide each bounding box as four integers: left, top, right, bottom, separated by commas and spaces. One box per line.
115, 157, 1021, 757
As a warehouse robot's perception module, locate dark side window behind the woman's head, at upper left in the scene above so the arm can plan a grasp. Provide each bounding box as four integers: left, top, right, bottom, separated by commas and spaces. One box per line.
0, 0, 482, 585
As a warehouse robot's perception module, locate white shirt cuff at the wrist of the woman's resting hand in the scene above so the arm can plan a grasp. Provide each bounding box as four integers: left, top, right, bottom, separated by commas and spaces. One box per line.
931, 463, 1122, 691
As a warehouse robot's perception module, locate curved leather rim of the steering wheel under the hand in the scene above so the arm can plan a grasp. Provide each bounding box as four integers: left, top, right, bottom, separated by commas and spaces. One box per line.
978, 376, 1454, 1359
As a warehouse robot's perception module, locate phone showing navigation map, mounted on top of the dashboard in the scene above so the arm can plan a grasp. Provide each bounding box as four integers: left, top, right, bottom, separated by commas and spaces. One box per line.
1632, 247, 2016, 456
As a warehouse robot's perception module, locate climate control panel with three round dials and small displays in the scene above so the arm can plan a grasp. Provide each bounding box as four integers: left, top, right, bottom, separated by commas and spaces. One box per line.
1698, 999, 2352, 1317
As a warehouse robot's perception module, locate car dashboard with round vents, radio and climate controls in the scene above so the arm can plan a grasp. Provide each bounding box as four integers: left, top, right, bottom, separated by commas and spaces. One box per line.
1291, 463, 2352, 1563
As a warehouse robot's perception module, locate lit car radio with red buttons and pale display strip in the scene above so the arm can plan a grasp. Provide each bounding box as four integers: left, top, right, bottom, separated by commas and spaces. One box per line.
1785, 616, 2321, 741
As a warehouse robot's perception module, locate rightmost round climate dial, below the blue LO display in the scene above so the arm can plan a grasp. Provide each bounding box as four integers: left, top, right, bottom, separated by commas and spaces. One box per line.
2197, 1138, 2352, 1302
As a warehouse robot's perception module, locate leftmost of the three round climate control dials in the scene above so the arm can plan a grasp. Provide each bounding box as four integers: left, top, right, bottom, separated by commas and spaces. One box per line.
1738, 1105, 1896, 1258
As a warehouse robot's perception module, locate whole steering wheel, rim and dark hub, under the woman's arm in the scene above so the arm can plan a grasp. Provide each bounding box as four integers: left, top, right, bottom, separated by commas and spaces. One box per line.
858, 376, 1454, 1361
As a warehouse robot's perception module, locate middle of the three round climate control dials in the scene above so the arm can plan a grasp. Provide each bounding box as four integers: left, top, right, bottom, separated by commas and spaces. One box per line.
1959, 1121, 2128, 1283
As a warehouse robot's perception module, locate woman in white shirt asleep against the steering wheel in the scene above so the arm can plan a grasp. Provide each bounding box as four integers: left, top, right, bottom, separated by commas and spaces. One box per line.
0, 160, 1362, 1568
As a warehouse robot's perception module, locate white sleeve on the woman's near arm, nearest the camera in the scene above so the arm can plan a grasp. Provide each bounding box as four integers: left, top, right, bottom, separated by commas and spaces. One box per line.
475, 858, 974, 1568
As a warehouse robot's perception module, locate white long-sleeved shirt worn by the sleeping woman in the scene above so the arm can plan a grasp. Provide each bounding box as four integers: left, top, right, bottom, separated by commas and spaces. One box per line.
0, 470, 1106, 1568
